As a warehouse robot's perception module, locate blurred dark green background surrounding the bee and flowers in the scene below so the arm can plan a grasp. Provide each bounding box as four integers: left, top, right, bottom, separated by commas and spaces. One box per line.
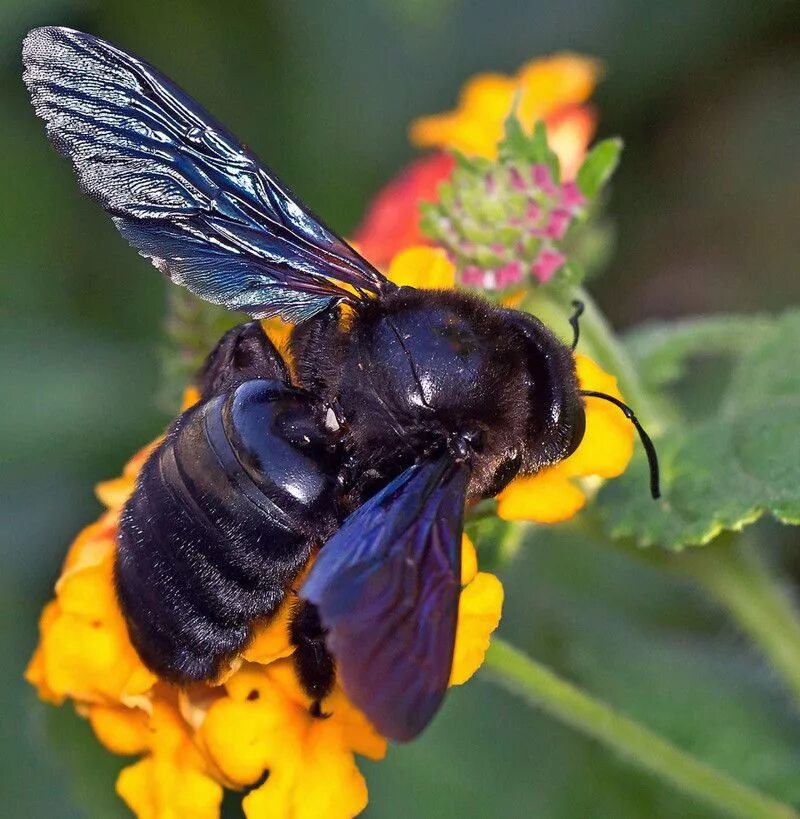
0, 0, 800, 819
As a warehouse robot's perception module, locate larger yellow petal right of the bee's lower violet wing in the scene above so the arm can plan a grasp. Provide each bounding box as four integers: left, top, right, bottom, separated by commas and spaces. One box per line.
450, 572, 503, 685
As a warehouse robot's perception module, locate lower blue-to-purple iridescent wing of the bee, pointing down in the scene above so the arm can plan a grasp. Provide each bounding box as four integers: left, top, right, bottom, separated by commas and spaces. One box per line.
300, 457, 469, 741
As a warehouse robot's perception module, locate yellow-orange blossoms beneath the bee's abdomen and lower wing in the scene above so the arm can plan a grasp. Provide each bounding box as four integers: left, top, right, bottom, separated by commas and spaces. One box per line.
25, 374, 502, 819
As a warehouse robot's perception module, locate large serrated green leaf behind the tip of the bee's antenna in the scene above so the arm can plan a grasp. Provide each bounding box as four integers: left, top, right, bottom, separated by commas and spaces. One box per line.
598, 311, 800, 549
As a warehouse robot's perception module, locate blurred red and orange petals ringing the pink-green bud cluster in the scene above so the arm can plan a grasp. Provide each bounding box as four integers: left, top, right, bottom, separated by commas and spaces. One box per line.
355, 54, 600, 267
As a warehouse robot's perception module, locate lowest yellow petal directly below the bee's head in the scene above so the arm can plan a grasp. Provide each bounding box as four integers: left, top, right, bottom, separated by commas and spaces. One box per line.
497, 466, 586, 523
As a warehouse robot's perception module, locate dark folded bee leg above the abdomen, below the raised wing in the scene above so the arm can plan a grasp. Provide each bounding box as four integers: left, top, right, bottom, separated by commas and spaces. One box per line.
196, 321, 289, 398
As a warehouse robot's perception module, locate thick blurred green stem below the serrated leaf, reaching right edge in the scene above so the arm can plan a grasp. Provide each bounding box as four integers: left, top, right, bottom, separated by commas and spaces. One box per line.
668, 536, 800, 699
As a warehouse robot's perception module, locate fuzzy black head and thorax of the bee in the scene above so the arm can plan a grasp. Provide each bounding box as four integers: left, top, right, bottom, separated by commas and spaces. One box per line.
330, 288, 585, 498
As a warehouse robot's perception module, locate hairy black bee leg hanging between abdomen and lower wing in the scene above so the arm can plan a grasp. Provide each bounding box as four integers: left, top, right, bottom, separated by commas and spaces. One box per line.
289, 601, 336, 719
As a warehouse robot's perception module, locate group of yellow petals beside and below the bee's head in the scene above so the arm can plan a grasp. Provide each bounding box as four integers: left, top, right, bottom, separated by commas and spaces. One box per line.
497, 355, 634, 523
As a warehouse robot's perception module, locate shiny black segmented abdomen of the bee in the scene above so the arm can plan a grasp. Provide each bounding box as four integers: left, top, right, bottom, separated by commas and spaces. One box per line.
116, 380, 336, 682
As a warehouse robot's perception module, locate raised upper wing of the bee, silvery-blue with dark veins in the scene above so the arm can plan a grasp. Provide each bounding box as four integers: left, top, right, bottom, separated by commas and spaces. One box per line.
23, 27, 387, 321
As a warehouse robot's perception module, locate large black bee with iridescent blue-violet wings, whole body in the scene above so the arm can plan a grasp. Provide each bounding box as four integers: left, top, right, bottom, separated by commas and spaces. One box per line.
23, 27, 658, 740
